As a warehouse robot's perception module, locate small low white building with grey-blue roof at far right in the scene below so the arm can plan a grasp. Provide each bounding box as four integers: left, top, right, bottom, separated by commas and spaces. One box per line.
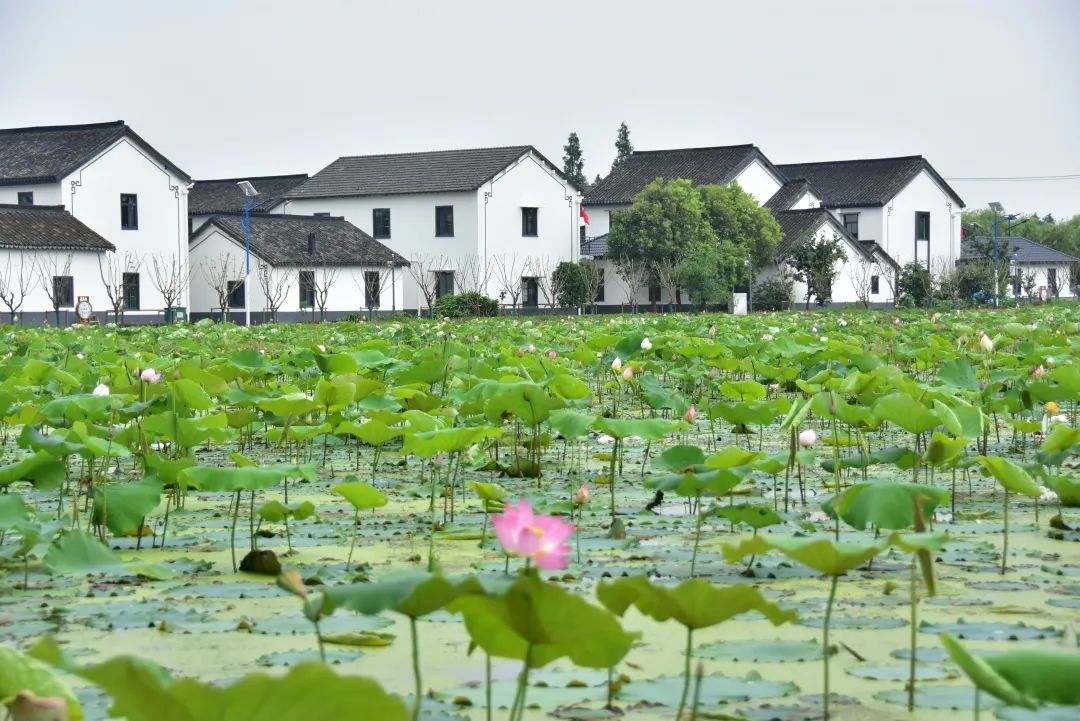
960, 235, 1080, 299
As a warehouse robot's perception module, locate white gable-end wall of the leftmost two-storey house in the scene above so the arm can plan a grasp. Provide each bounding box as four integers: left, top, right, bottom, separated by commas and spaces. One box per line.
60, 138, 189, 310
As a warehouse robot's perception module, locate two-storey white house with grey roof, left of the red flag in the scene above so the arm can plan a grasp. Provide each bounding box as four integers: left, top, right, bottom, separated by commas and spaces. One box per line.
273, 146, 581, 310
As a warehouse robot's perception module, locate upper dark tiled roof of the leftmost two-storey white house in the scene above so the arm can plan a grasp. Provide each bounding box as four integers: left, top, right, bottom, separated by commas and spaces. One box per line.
0, 120, 191, 186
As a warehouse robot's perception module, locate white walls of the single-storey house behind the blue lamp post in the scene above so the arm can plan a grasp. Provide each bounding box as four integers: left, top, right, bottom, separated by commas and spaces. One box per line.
191, 227, 408, 313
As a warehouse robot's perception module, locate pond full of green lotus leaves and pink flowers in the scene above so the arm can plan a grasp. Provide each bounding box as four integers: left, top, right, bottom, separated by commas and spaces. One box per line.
0, 305, 1080, 721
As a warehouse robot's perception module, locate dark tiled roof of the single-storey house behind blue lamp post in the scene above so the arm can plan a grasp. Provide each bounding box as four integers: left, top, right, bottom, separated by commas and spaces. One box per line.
191, 213, 408, 267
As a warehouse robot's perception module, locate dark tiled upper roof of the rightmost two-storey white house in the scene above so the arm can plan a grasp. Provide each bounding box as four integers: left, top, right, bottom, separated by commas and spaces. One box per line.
778, 155, 963, 208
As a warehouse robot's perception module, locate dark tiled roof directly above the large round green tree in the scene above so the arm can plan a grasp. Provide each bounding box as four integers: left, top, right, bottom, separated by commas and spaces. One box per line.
584, 145, 783, 205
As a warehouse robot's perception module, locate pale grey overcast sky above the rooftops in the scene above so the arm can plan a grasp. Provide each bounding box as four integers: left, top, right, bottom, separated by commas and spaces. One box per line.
0, 0, 1080, 217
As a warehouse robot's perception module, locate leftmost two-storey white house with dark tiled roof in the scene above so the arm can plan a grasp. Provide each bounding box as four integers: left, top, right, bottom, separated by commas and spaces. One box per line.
0, 121, 191, 324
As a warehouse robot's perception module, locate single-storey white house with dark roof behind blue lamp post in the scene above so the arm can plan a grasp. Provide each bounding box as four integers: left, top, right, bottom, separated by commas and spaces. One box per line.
191, 213, 408, 323
